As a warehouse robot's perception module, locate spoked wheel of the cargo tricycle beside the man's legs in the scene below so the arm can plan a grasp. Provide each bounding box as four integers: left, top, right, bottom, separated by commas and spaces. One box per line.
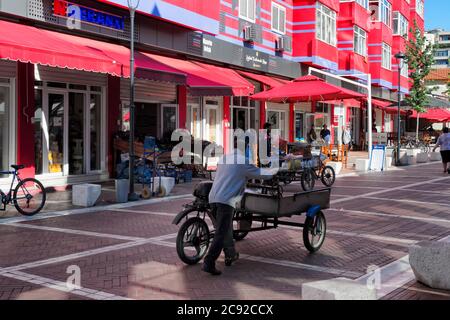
177, 217, 211, 265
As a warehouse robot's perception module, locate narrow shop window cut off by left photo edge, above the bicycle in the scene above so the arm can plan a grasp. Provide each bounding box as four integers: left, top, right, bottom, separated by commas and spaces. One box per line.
0, 86, 10, 178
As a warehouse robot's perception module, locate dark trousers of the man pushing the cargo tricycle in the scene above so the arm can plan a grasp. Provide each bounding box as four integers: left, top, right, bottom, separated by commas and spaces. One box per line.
205, 203, 236, 266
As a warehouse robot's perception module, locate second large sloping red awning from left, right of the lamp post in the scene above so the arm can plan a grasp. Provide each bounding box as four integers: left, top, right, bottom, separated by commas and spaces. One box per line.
144, 53, 254, 96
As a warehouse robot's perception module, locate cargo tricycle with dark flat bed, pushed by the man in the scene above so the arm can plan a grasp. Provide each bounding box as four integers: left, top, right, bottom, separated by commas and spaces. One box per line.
173, 182, 331, 265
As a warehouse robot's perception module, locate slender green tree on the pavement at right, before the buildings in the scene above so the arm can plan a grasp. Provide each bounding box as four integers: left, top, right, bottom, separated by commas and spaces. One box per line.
405, 21, 435, 139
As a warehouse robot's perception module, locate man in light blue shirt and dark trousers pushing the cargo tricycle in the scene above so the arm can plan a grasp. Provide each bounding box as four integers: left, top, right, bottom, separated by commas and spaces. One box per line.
202, 139, 277, 276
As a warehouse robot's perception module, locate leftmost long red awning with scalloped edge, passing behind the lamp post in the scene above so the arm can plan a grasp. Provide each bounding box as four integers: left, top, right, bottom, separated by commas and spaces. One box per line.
0, 21, 186, 84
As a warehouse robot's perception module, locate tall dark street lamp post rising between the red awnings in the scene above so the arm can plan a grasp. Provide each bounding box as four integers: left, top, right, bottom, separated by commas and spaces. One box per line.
127, 0, 140, 201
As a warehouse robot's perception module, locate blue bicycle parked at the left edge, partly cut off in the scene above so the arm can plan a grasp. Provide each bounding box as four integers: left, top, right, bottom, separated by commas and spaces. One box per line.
0, 164, 47, 216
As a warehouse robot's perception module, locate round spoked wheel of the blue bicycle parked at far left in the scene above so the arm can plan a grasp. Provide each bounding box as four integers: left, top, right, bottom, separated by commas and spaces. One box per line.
13, 178, 47, 216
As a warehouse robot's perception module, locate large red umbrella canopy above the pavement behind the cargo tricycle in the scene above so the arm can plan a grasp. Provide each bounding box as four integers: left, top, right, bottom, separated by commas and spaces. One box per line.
251, 76, 365, 103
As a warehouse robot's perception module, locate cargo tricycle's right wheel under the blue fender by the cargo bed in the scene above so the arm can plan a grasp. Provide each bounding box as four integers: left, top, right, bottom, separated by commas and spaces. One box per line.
303, 211, 327, 253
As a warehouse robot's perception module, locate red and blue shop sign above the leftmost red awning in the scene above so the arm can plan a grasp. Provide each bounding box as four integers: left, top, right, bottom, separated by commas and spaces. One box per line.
53, 0, 125, 31
